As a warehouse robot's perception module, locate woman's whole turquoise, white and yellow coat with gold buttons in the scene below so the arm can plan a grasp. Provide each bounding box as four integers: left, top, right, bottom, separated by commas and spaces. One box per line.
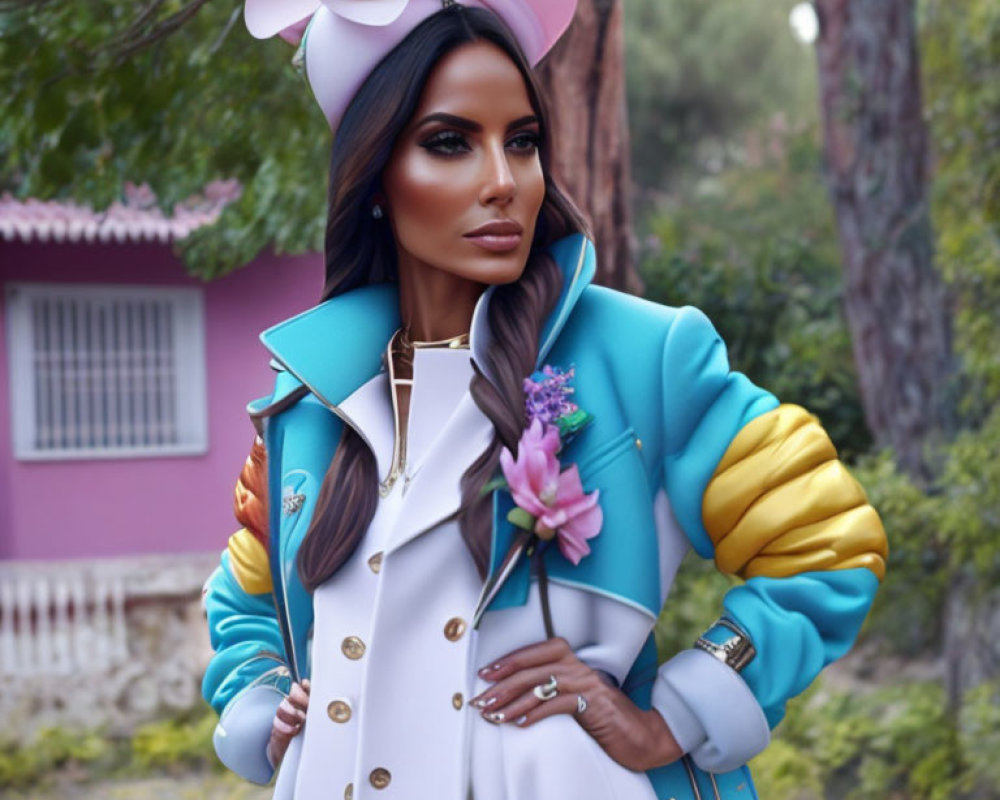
204, 236, 885, 800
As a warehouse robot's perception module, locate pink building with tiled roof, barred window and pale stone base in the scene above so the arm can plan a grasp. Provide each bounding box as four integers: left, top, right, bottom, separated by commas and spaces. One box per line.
0, 192, 323, 732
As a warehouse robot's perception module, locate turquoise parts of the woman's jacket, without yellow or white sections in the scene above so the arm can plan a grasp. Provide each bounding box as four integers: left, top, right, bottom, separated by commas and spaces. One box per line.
203, 230, 884, 800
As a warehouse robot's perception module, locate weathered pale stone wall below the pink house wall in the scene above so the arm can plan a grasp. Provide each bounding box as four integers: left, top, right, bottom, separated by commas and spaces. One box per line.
0, 554, 218, 739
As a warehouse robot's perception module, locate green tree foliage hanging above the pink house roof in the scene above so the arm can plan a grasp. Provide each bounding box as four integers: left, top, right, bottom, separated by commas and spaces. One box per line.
0, 0, 330, 277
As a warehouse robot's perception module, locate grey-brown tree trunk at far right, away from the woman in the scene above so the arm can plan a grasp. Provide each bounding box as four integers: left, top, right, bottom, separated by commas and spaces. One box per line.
815, 0, 952, 482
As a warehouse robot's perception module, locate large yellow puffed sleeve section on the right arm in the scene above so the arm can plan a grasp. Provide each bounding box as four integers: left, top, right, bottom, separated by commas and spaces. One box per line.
702, 405, 888, 580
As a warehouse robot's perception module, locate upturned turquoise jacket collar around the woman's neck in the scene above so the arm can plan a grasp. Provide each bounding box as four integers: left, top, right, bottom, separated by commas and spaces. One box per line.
260, 234, 596, 416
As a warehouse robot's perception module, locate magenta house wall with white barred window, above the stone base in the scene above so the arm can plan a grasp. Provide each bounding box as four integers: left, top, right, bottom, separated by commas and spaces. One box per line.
0, 189, 322, 560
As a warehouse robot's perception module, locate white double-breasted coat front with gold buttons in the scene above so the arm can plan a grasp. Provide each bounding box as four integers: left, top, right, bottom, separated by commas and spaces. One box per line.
275, 350, 752, 800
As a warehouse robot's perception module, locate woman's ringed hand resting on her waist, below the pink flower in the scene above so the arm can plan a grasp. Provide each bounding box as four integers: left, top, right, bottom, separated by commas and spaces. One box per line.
471, 637, 683, 772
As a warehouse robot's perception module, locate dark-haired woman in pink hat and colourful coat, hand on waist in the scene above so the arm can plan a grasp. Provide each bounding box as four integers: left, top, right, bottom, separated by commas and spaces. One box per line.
204, 0, 885, 800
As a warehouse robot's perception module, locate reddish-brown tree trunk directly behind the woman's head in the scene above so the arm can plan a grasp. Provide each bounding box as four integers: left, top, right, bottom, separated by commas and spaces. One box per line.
539, 0, 642, 292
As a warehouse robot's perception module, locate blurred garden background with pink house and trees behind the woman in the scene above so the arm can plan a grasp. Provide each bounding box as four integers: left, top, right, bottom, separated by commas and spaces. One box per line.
0, 0, 1000, 800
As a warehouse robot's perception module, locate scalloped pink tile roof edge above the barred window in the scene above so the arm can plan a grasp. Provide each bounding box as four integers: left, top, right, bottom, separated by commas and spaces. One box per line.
0, 181, 240, 242
